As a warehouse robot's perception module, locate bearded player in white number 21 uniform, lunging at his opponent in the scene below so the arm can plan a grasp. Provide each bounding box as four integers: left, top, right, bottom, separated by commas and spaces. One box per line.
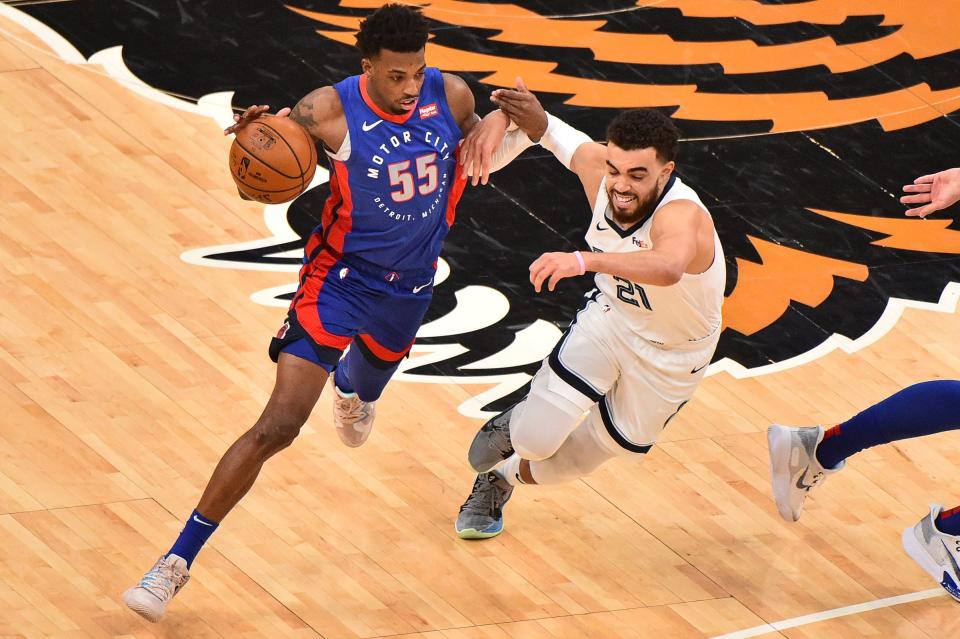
456, 81, 726, 539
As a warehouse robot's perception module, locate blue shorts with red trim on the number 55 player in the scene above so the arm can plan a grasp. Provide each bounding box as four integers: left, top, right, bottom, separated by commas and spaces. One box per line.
270, 249, 436, 371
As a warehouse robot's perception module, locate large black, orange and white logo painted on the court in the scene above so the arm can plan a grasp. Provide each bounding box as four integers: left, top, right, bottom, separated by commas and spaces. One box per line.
13, 0, 960, 414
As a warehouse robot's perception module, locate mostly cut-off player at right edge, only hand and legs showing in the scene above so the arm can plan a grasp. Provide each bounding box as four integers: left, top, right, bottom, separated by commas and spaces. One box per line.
767, 168, 960, 601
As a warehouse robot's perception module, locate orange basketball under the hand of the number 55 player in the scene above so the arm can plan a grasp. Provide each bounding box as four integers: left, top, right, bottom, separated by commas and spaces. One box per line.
230, 115, 317, 204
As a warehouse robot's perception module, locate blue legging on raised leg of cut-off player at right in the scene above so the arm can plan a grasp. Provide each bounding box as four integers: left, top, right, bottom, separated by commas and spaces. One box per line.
816, 380, 960, 468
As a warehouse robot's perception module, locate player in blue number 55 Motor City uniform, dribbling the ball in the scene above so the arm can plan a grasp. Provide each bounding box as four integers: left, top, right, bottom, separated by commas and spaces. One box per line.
124, 4, 479, 621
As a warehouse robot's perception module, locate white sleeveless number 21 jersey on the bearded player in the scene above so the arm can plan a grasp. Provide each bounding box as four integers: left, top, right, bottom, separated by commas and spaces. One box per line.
585, 176, 726, 348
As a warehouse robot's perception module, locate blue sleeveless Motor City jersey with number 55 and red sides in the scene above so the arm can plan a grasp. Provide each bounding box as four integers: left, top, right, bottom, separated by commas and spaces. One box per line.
317, 68, 466, 271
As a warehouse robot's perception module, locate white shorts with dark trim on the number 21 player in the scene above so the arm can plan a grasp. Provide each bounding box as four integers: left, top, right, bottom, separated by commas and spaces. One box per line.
533, 293, 719, 453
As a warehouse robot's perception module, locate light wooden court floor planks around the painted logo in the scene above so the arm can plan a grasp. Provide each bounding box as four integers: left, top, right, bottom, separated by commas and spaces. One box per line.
0, 5, 960, 639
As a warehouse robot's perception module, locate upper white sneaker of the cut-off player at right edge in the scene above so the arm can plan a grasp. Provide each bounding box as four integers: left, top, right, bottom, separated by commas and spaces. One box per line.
767, 424, 847, 521
